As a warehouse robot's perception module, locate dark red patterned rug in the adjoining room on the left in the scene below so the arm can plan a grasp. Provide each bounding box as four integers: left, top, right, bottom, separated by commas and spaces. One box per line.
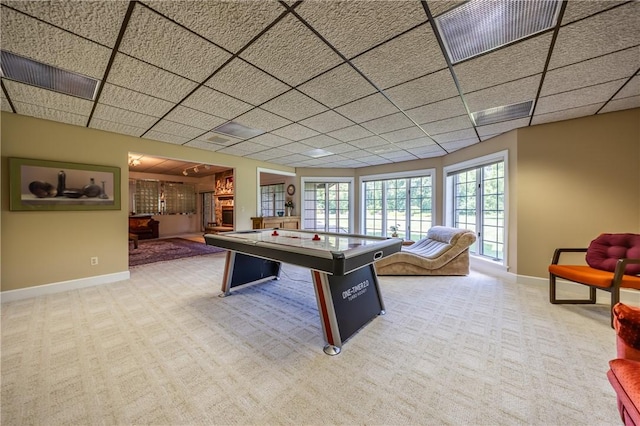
129, 238, 224, 266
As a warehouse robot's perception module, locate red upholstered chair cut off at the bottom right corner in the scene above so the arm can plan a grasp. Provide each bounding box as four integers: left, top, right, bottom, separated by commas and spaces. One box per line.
607, 303, 640, 426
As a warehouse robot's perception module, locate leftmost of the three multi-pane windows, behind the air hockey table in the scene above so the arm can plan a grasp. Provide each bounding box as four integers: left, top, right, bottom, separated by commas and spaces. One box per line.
301, 178, 353, 233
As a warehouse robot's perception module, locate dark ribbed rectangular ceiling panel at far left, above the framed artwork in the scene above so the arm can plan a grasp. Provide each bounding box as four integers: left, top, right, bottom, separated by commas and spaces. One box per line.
2, 50, 98, 101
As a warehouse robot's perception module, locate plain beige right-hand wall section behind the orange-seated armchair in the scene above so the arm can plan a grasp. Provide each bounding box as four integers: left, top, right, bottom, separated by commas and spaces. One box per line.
515, 109, 640, 277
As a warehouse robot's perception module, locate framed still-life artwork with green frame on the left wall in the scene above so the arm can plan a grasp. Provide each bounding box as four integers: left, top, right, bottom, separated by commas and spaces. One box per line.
9, 158, 120, 211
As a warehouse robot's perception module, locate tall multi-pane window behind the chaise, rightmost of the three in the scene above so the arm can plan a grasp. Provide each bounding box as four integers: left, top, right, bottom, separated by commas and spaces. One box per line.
445, 151, 507, 262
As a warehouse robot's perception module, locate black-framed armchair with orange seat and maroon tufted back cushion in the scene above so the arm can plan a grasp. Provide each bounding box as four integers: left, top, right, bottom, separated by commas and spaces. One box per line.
549, 234, 640, 327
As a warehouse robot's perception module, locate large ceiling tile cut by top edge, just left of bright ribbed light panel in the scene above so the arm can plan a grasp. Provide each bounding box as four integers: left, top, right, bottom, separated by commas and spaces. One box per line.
296, 1, 427, 58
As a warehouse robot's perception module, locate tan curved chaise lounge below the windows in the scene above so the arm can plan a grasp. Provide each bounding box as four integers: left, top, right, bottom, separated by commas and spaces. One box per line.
375, 226, 476, 275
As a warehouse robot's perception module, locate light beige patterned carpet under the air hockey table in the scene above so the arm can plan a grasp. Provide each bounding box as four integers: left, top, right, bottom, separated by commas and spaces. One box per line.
1, 254, 620, 425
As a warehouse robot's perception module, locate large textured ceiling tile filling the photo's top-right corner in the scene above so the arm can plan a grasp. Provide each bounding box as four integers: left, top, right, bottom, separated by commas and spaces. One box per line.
549, 1, 640, 70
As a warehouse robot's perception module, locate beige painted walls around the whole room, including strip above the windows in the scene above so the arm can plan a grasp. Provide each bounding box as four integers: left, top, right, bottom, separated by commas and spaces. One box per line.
1, 109, 640, 291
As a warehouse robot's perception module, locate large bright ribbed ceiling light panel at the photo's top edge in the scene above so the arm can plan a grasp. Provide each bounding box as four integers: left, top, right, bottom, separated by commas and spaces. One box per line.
435, 0, 562, 64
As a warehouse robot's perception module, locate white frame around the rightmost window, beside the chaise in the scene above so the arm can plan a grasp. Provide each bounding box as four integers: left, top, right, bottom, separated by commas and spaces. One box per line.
442, 150, 509, 267
